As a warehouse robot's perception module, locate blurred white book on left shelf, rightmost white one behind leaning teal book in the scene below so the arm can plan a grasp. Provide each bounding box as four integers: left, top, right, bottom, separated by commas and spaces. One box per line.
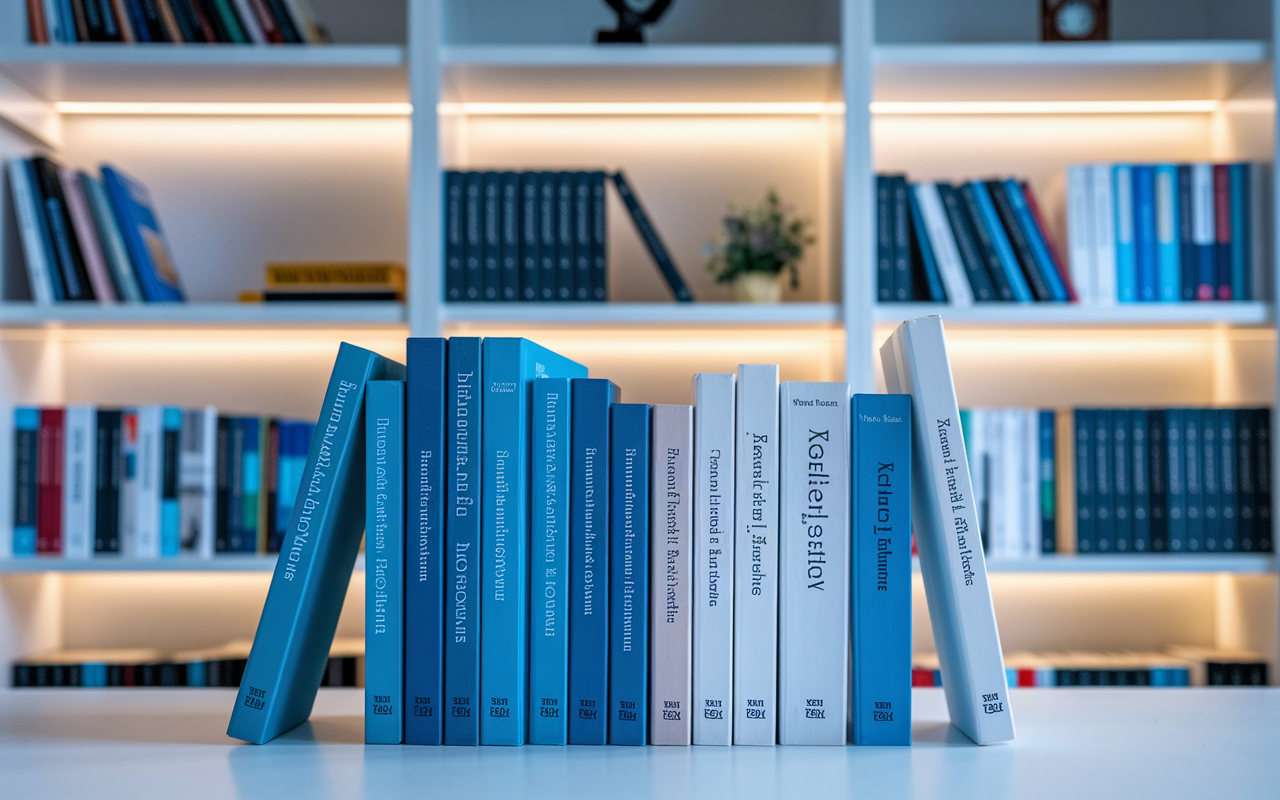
178, 406, 218, 558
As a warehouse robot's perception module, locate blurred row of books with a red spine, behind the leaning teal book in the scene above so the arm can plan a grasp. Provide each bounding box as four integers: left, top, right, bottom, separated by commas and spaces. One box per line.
13, 406, 315, 558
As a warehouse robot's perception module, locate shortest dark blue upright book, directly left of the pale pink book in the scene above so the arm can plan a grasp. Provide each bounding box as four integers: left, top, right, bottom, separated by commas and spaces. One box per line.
608, 403, 649, 745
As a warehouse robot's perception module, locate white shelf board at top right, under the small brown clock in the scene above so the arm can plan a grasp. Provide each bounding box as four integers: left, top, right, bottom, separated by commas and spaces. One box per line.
872, 41, 1270, 101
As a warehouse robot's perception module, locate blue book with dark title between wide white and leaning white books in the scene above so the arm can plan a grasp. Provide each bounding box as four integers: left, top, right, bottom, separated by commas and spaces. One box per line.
849, 394, 911, 745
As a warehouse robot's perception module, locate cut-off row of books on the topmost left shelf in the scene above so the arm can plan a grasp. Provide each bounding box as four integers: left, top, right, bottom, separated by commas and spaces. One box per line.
27, 0, 329, 45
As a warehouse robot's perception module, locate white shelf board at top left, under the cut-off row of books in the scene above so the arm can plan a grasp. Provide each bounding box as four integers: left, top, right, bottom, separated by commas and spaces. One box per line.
0, 45, 408, 102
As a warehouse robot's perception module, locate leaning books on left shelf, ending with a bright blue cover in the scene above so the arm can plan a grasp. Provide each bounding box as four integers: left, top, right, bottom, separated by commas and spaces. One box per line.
5, 156, 183, 305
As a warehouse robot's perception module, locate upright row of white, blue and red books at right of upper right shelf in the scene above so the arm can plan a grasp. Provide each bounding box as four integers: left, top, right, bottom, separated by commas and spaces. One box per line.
1066, 163, 1271, 306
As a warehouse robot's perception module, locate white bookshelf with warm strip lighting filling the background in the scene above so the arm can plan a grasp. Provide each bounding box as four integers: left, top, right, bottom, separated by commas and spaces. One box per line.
0, 0, 1280, 686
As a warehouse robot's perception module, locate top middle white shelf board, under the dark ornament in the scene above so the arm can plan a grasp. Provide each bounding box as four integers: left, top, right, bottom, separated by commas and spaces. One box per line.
440, 45, 840, 102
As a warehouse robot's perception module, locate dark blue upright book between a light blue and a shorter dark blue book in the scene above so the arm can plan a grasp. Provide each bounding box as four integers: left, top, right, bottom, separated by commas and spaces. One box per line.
568, 378, 618, 745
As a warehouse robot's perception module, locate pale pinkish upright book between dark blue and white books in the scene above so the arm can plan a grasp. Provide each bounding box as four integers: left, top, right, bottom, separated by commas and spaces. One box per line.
649, 404, 694, 745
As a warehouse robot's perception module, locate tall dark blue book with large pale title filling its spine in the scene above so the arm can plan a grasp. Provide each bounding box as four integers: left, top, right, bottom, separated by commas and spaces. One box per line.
444, 337, 484, 745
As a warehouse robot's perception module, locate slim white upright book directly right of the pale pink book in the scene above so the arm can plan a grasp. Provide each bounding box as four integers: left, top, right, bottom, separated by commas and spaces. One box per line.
692, 372, 737, 745
